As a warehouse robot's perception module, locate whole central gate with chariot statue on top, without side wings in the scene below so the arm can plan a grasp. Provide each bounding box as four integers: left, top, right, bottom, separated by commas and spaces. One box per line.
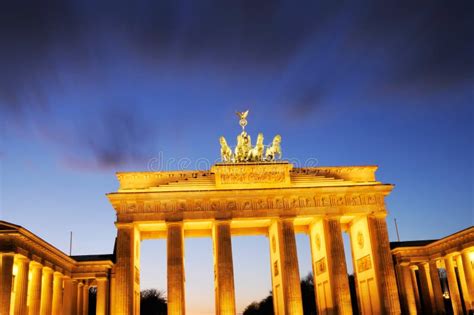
108, 111, 400, 315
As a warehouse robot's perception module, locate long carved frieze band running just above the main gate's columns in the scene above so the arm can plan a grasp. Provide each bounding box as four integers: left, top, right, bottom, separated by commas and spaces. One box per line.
114, 194, 384, 213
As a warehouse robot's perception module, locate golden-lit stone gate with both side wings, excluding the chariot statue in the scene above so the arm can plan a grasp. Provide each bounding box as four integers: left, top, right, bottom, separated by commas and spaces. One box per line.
0, 162, 474, 315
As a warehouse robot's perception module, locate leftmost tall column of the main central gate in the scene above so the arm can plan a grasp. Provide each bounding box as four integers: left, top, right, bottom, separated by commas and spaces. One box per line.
111, 225, 140, 315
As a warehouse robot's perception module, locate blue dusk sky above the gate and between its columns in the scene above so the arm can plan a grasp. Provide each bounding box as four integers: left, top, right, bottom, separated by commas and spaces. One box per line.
0, 1, 474, 314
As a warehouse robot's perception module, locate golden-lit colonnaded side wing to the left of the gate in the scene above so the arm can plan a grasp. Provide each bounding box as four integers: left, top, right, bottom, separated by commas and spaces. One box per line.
0, 221, 113, 315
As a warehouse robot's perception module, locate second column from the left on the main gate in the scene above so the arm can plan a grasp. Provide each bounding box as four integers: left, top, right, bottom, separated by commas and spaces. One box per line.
166, 222, 185, 315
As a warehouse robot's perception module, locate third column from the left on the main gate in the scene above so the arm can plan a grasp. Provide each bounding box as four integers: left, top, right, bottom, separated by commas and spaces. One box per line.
212, 221, 236, 315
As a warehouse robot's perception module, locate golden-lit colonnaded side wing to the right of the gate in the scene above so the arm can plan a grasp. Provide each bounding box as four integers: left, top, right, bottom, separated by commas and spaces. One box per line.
391, 227, 474, 314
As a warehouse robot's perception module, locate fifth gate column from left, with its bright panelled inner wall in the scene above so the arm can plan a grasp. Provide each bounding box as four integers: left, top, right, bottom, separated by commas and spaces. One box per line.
309, 218, 352, 314
